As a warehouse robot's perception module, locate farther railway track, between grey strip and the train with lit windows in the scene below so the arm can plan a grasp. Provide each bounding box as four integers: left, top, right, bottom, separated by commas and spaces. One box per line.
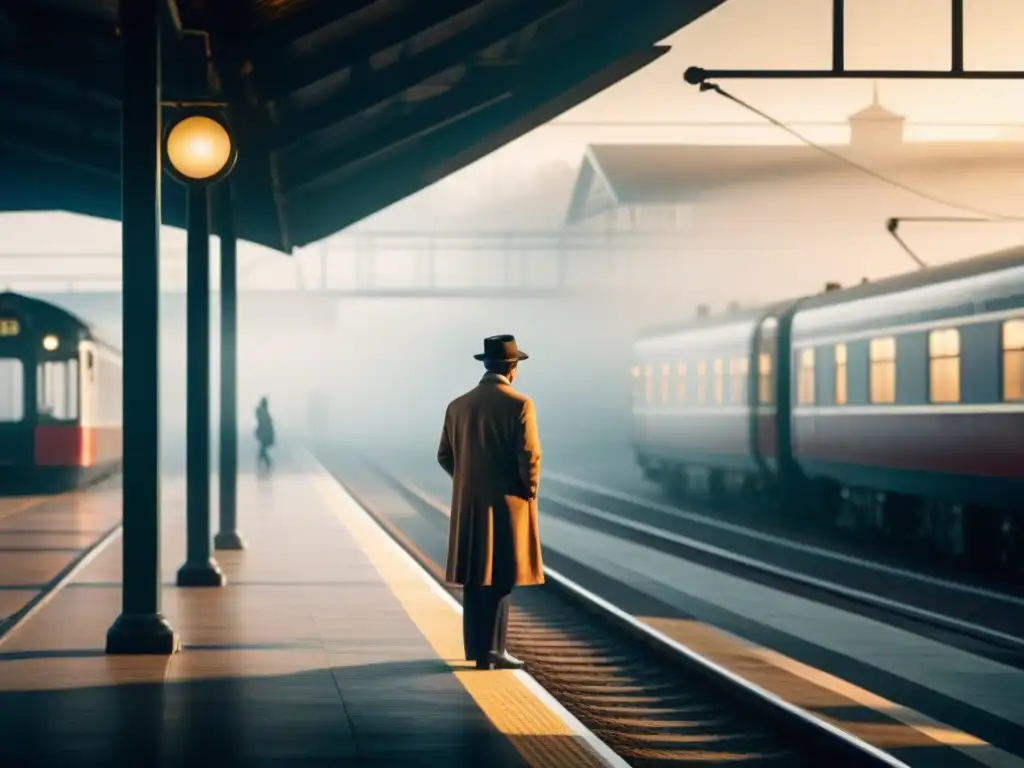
543, 475, 1024, 665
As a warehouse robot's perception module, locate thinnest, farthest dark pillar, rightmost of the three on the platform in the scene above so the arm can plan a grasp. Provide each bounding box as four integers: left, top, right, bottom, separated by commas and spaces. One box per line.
213, 181, 246, 550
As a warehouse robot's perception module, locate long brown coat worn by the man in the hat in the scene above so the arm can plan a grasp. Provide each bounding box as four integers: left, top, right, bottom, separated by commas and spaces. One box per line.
437, 374, 544, 587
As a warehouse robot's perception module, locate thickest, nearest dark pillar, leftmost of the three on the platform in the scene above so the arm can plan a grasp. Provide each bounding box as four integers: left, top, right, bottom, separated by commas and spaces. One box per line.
106, 0, 179, 654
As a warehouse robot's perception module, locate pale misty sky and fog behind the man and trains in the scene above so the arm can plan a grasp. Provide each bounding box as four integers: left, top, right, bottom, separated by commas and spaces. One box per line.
0, 0, 1024, 468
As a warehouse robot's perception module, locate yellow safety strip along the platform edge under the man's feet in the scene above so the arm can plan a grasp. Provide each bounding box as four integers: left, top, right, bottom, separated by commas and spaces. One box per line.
317, 468, 606, 768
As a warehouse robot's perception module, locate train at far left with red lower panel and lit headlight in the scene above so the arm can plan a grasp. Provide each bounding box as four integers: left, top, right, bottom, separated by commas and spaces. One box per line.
0, 293, 122, 492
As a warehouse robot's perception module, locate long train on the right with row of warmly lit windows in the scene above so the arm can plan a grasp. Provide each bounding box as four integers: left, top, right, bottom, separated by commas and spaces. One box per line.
632, 248, 1024, 573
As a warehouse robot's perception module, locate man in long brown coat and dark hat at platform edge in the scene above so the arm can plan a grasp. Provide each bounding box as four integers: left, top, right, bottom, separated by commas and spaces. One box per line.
437, 335, 544, 669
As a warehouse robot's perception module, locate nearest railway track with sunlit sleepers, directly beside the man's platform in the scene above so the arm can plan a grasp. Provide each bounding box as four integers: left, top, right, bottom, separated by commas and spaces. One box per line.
321, 460, 904, 768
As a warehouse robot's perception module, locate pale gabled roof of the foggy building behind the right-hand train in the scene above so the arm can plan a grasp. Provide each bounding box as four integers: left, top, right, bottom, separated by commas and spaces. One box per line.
566, 138, 1024, 224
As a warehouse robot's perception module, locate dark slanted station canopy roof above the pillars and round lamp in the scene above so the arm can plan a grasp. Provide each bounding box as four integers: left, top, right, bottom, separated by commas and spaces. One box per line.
0, 0, 723, 252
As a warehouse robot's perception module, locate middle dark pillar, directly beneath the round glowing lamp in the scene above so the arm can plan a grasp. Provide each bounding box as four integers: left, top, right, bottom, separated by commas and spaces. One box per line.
178, 184, 224, 587
